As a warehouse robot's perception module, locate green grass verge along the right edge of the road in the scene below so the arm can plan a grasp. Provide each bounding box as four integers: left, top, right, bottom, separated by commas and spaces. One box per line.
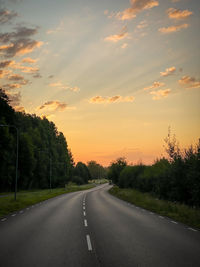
109, 186, 200, 229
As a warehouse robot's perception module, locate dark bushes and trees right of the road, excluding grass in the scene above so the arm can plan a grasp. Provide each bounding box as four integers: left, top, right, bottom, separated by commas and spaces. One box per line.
108, 131, 200, 207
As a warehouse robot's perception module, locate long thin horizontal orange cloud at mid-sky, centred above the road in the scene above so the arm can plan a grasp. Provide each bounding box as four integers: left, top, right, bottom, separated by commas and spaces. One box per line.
89, 95, 135, 104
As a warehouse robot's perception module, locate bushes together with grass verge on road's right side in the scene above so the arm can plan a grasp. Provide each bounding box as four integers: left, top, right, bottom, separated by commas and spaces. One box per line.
108, 129, 200, 228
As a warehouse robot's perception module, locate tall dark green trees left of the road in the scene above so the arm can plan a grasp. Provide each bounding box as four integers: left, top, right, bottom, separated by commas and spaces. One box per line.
0, 89, 103, 192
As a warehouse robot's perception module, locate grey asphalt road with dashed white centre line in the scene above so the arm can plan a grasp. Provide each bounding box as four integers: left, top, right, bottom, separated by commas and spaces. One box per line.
0, 185, 200, 267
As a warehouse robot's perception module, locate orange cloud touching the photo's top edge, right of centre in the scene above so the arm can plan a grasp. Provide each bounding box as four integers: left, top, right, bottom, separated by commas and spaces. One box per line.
115, 0, 159, 20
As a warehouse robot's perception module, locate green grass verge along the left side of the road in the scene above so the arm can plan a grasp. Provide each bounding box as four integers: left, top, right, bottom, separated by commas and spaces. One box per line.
0, 183, 94, 218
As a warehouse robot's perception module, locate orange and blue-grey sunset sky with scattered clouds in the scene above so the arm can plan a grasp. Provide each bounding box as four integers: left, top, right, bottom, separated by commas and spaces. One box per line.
0, 0, 200, 166
